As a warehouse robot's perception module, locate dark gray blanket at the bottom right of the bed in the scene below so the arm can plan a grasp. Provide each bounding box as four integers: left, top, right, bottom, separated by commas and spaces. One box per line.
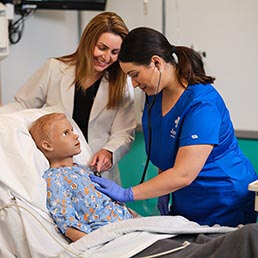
133, 223, 258, 258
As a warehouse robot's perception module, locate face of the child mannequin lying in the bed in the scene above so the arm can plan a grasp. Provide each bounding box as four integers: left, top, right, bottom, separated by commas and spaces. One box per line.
45, 118, 81, 160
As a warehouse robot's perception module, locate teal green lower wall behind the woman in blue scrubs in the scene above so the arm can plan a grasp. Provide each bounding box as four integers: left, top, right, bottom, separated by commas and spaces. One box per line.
119, 132, 258, 216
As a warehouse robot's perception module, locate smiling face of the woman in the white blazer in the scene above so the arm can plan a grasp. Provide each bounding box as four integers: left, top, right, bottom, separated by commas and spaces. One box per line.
93, 32, 122, 72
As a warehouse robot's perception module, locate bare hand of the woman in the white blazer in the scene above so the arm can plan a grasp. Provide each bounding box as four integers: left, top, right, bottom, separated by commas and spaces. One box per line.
90, 149, 113, 172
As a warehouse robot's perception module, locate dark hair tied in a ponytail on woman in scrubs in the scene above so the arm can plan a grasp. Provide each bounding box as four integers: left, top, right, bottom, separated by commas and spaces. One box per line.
118, 27, 215, 84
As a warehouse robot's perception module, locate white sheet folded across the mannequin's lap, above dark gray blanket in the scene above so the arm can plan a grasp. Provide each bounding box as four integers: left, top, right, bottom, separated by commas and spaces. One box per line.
66, 216, 236, 258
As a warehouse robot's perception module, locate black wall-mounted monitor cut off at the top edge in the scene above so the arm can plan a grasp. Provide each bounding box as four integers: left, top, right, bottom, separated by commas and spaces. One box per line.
15, 0, 107, 11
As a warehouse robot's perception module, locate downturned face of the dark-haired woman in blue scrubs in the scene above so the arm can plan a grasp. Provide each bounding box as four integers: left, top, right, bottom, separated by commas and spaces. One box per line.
120, 62, 162, 96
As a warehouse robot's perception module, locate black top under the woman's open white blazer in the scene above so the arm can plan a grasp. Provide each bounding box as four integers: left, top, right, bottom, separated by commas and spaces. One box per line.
73, 78, 101, 142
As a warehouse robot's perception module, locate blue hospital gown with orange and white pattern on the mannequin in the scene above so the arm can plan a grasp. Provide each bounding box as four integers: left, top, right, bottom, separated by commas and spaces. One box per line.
43, 164, 133, 234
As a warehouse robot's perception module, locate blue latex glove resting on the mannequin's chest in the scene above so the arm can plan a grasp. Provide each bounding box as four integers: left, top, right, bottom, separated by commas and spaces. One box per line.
90, 174, 134, 202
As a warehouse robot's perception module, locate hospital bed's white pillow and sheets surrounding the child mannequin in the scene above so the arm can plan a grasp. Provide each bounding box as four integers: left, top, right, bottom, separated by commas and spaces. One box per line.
0, 106, 258, 258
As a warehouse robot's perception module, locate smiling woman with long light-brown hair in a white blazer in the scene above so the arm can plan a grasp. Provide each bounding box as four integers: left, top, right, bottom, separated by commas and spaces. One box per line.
0, 12, 136, 183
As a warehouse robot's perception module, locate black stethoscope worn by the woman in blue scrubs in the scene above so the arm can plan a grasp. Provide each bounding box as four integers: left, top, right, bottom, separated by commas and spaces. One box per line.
140, 69, 161, 184
